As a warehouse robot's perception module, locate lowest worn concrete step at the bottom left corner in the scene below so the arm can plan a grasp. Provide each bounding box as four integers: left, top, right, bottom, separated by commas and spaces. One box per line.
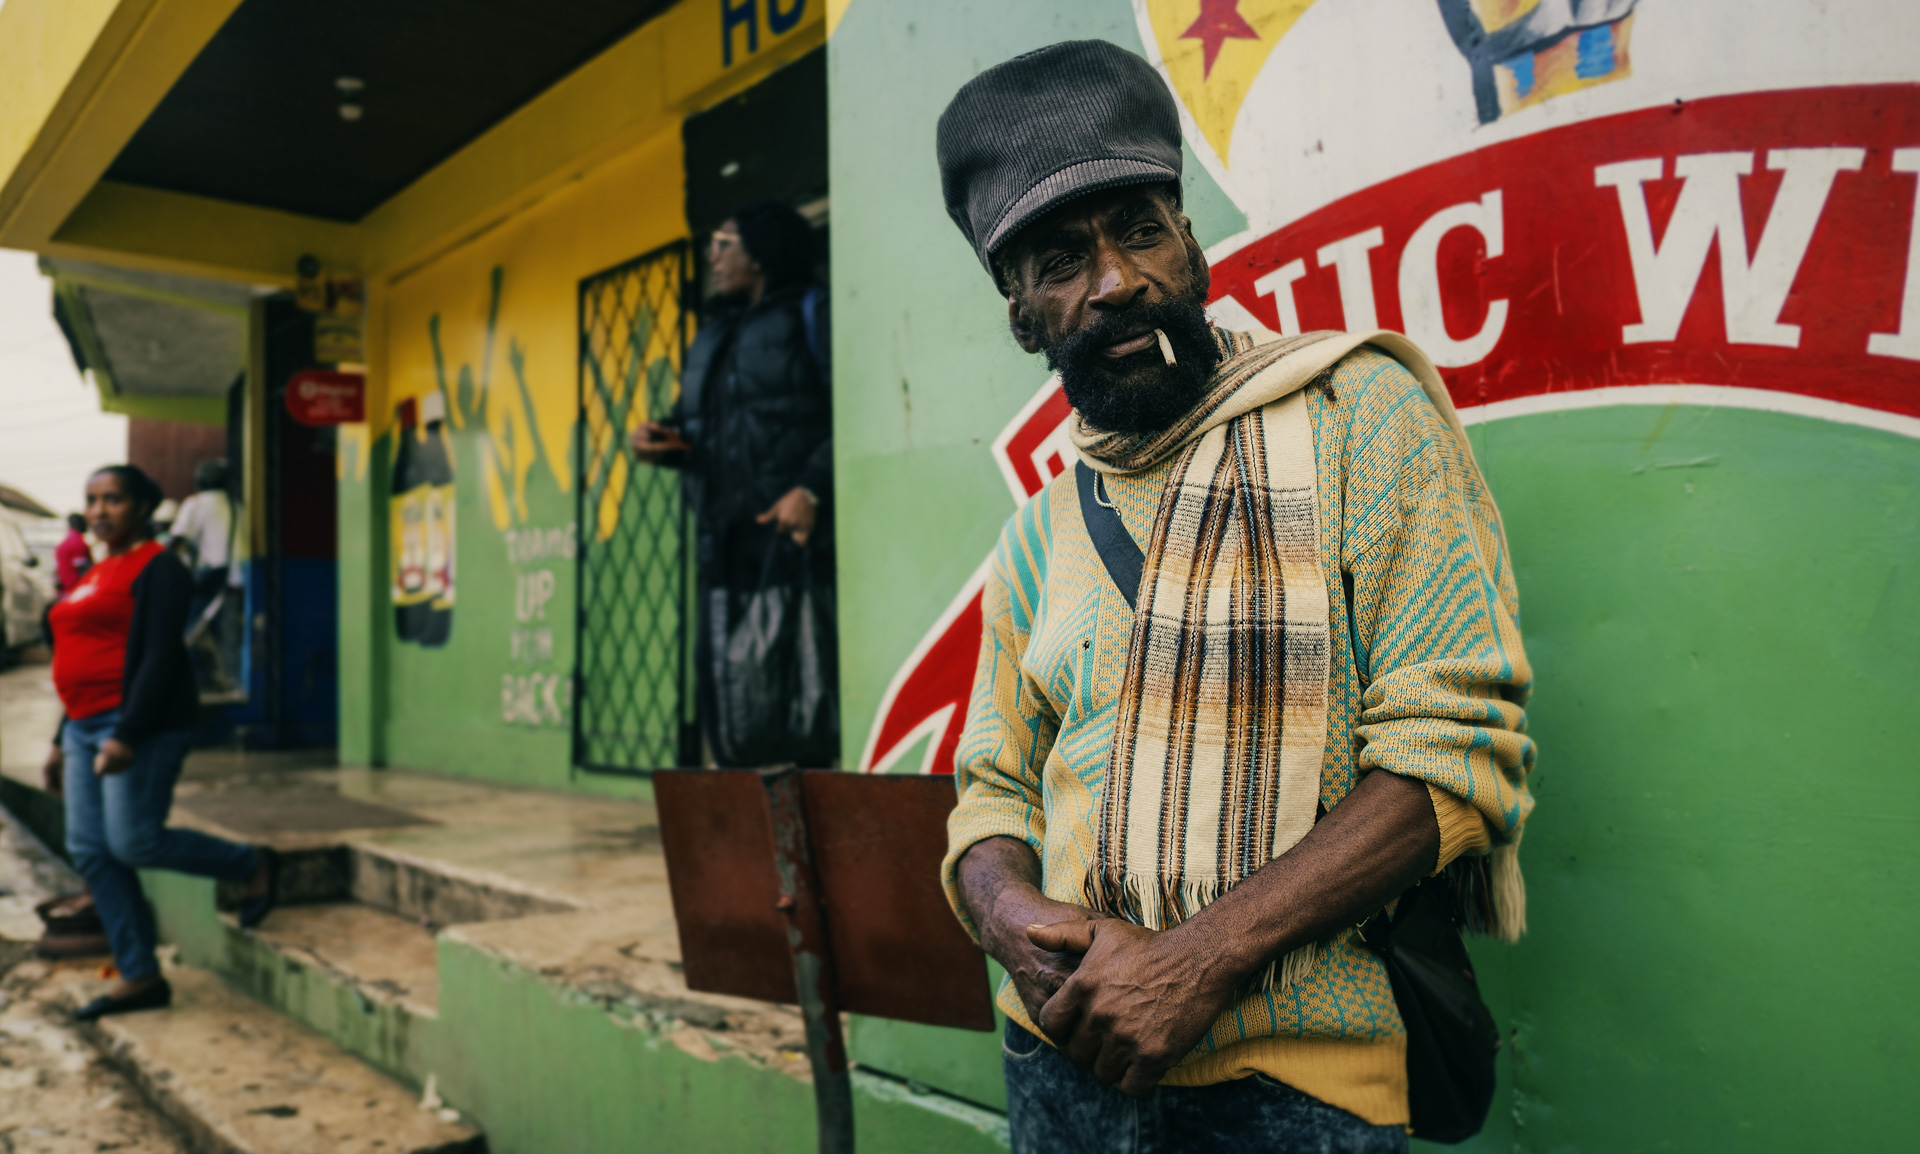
71, 966, 486, 1154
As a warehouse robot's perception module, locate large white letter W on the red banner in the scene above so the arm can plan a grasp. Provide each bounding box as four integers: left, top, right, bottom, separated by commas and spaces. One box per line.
1594, 148, 1866, 349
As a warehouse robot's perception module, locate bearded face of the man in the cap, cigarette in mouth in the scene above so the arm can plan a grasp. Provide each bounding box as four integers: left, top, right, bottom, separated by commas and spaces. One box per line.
1000, 186, 1219, 434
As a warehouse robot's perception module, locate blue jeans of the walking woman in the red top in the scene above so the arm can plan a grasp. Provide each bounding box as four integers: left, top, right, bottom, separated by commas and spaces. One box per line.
61, 709, 259, 981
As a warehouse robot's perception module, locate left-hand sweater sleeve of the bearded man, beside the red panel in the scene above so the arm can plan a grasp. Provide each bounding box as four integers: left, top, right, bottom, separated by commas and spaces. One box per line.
941, 493, 1060, 941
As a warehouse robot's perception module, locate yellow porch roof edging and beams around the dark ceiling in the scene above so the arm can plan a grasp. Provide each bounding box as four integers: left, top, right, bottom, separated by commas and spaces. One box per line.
0, 0, 826, 286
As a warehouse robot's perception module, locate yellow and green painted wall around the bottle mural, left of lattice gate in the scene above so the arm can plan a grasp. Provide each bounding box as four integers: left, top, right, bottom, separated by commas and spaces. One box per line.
342, 114, 687, 791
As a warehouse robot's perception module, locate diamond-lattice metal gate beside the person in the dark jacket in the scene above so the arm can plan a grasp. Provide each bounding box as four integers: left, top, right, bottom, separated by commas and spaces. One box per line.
574, 242, 699, 774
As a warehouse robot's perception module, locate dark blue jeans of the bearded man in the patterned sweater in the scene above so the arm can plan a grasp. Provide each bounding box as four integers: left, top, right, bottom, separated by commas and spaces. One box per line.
1000, 1022, 1407, 1154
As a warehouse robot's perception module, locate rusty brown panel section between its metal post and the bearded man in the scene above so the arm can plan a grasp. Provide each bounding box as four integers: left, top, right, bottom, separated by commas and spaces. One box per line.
802, 772, 993, 1029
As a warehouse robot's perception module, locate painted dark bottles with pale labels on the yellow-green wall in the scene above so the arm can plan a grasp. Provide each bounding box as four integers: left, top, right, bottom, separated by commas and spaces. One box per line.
392, 392, 455, 649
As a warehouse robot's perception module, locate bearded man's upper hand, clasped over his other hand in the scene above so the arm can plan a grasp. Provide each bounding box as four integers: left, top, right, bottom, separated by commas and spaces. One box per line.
1027, 918, 1233, 1096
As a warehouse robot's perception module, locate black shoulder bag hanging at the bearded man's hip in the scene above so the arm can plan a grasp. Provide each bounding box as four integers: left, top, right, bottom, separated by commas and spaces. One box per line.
1359, 878, 1500, 1142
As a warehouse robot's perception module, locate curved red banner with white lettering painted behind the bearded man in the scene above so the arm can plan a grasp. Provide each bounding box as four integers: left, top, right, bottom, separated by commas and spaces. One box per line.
860, 84, 1920, 774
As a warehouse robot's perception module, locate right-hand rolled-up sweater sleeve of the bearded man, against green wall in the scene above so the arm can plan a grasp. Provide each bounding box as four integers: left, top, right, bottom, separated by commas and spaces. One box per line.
1338, 353, 1534, 841
